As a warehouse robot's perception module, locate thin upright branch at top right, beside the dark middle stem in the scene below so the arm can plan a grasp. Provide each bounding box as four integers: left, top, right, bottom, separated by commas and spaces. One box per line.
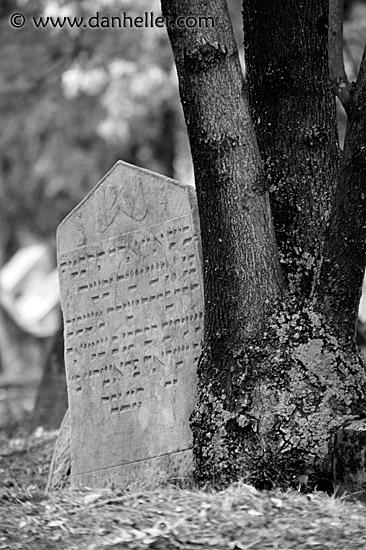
328, 0, 351, 110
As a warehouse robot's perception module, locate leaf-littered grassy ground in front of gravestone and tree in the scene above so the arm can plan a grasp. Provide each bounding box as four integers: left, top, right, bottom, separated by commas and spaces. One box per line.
0, 430, 366, 550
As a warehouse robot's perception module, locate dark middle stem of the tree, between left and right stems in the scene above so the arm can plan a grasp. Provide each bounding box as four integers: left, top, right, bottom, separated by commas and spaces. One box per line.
243, 0, 339, 296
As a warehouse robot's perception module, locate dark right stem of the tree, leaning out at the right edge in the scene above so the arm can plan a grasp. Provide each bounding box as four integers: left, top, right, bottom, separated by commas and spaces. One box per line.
315, 47, 366, 340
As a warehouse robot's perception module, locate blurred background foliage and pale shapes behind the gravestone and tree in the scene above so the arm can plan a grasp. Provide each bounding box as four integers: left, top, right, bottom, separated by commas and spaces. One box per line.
0, 0, 366, 438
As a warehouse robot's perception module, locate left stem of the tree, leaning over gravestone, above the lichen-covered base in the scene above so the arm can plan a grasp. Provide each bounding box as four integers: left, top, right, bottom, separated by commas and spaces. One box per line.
162, 1, 281, 336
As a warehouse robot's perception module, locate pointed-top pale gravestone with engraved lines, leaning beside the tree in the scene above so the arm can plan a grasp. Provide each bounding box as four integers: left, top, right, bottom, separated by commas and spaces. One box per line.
57, 161, 203, 487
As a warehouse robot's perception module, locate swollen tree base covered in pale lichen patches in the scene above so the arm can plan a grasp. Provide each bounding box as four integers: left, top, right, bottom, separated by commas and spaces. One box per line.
192, 302, 366, 488
